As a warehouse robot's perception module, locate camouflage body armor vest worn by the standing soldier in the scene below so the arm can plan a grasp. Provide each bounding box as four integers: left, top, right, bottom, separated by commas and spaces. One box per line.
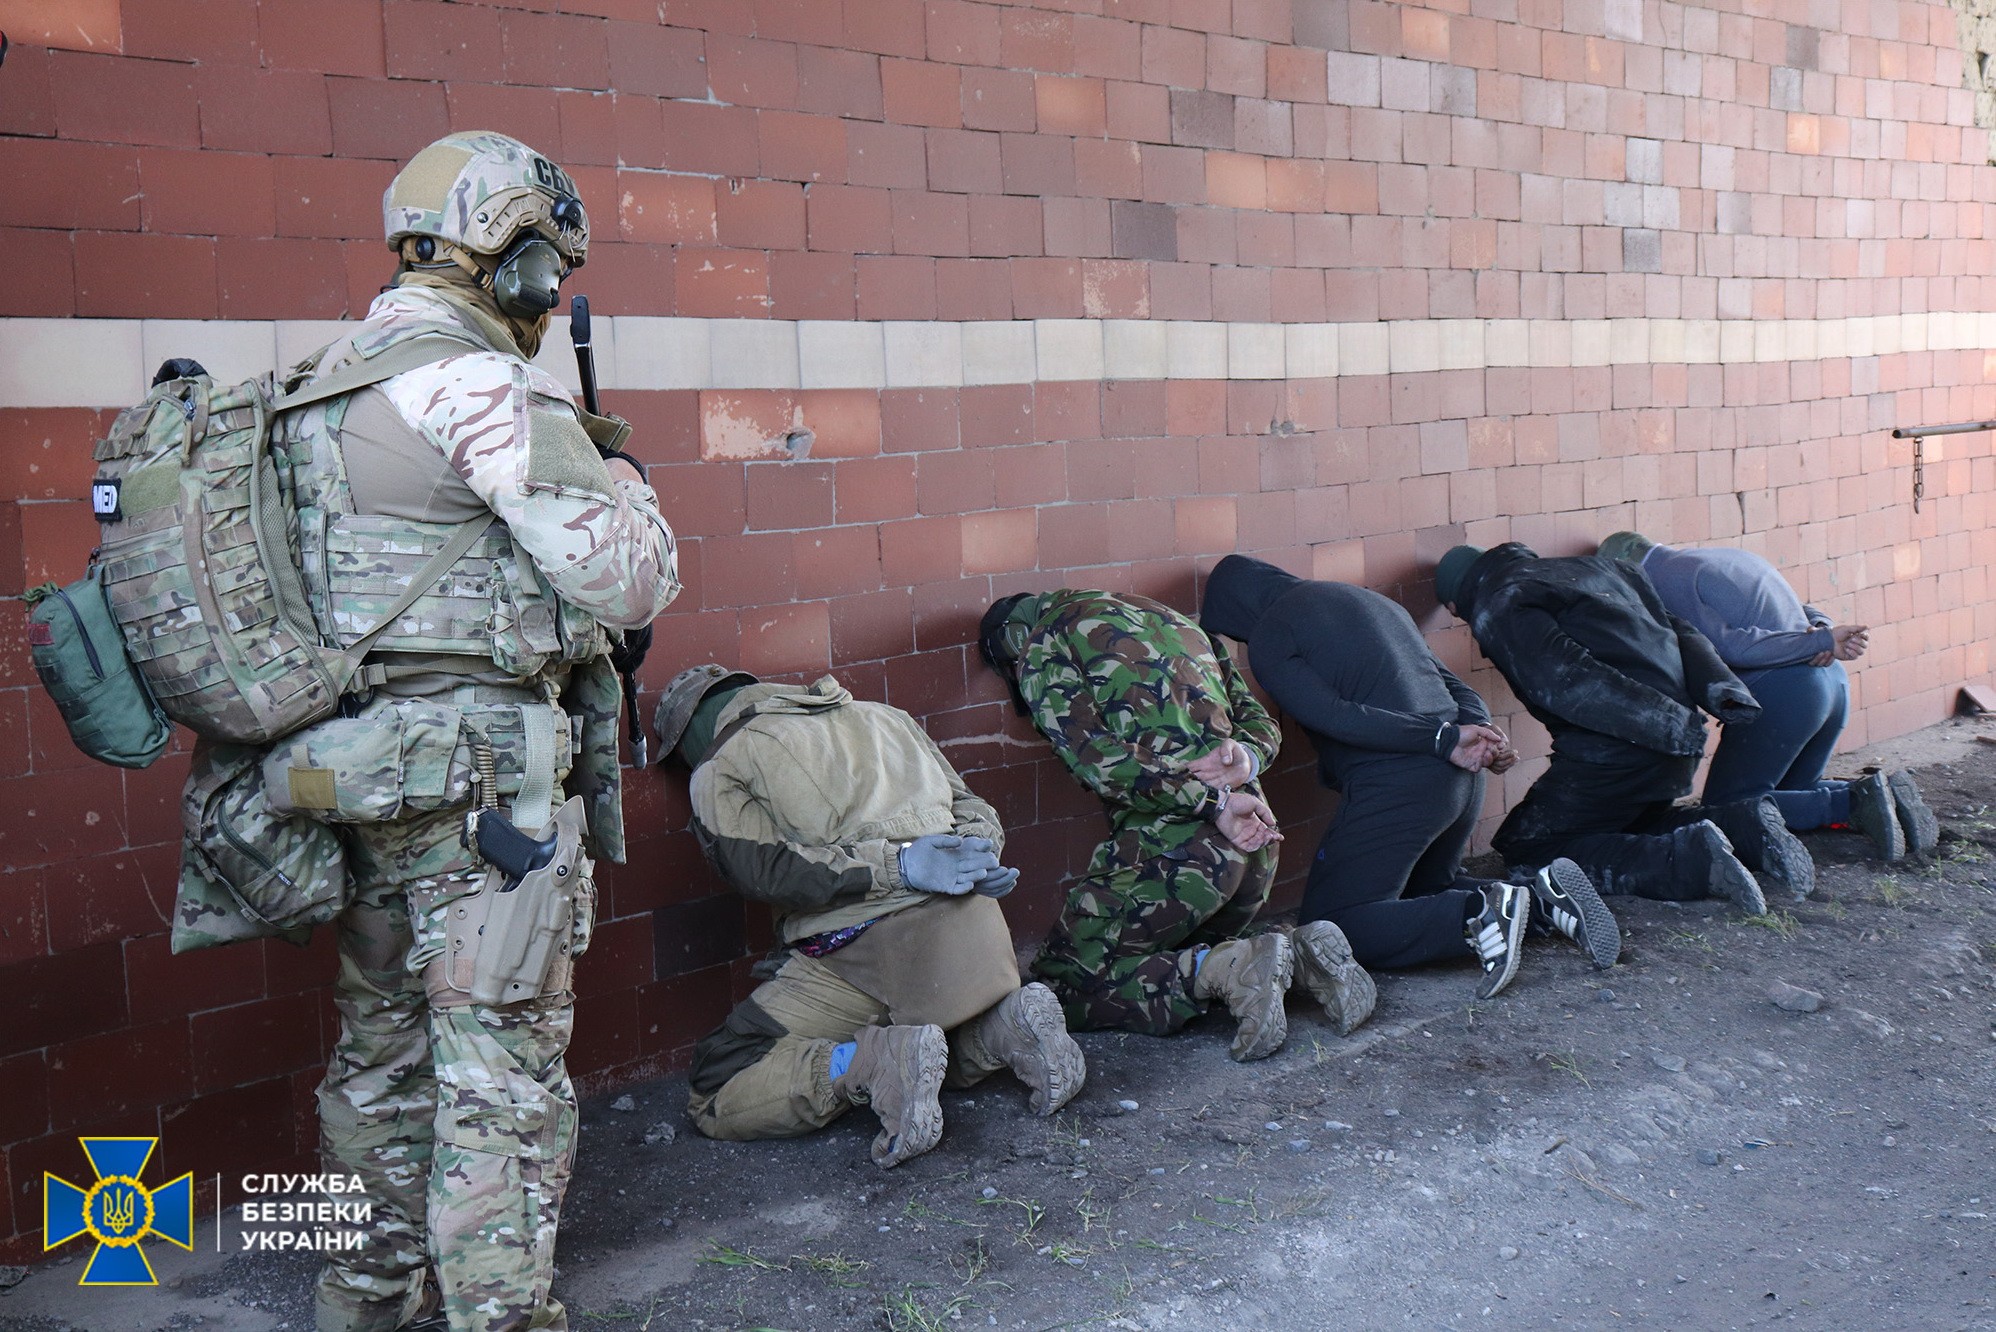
273, 301, 609, 681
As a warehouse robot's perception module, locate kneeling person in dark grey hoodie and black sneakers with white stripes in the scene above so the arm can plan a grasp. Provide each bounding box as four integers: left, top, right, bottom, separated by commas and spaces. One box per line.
1200, 555, 1621, 997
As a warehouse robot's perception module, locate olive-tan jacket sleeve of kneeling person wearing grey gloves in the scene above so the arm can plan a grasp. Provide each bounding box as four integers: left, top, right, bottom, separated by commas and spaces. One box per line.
691, 739, 910, 913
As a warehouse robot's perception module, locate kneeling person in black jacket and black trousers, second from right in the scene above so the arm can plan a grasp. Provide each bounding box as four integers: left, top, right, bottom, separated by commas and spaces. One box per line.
1435, 541, 1814, 915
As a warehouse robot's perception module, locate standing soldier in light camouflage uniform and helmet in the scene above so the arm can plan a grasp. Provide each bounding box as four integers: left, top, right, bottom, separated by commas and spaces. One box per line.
263, 134, 679, 1332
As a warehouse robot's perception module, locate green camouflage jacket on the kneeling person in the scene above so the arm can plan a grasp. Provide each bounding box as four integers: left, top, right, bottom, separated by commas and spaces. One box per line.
1018, 587, 1281, 855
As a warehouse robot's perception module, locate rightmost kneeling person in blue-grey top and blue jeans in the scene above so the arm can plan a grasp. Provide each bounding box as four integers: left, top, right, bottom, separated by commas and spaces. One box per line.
1599, 531, 1940, 861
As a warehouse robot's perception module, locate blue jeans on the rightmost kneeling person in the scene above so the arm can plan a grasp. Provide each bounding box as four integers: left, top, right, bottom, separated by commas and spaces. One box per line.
1705, 661, 1850, 831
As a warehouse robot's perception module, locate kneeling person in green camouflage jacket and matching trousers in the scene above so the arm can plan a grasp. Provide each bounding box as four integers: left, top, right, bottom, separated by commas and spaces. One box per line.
978, 589, 1369, 1060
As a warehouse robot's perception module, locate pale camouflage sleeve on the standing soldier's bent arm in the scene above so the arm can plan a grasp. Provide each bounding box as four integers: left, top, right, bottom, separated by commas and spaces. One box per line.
383, 353, 679, 629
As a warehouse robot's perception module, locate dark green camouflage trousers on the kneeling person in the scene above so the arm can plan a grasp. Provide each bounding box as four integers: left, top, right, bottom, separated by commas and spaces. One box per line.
1032, 825, 1275, 1036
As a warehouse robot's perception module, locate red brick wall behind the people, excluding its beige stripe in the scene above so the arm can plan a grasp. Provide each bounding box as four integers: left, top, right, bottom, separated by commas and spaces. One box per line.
0, 0, 1996, 1260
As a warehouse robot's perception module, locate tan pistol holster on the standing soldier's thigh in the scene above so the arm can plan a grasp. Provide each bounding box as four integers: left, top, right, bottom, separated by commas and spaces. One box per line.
423, 797, 597, 1008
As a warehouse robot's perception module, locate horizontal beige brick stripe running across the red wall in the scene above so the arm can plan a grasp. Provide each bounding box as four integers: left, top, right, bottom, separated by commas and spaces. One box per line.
0, 312, 1996, 407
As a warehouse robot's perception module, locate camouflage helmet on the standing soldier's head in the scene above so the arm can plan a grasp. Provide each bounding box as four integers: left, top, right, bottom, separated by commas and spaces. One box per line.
381, 130, 589, 268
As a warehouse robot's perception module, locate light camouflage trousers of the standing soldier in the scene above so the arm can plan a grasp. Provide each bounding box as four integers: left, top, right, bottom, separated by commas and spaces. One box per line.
317, 811, 587, 1332
